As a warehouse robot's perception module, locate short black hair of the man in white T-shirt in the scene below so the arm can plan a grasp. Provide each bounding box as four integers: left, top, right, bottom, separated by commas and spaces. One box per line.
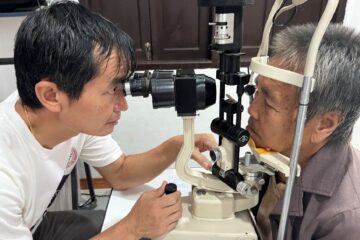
14, 1, 135, 109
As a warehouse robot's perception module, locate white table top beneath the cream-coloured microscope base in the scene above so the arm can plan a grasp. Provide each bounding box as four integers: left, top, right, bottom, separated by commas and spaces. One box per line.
102, 169, 257, 240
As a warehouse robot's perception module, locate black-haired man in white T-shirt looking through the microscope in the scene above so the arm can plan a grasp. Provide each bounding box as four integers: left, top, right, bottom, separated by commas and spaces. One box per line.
0, 1, 216, 239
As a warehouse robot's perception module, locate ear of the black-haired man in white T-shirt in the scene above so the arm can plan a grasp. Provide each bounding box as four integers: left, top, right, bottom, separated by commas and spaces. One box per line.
35, 79, 61, 112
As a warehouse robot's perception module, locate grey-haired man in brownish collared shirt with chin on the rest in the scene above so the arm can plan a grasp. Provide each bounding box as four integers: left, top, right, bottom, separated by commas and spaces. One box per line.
247, 24, 360, 240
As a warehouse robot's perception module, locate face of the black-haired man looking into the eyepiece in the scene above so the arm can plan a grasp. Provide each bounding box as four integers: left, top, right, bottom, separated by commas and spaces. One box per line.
57, 52, 128, 136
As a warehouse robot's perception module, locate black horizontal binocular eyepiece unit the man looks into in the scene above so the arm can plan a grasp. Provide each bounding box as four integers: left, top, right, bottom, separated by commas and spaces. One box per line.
124, 70, 216, 116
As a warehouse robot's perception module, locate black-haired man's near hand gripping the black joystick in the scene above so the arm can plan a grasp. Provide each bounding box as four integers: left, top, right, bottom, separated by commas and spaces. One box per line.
126, 182, 182, 239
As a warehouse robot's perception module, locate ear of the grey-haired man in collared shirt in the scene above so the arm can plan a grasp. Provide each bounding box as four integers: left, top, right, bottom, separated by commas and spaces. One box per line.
311, 112, 341, 143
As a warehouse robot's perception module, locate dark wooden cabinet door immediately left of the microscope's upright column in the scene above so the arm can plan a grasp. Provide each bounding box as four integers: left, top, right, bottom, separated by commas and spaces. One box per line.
150, 0, 210, 61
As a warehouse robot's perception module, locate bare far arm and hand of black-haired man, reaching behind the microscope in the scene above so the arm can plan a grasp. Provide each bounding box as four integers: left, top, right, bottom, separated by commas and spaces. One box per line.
96, 134, 217, 190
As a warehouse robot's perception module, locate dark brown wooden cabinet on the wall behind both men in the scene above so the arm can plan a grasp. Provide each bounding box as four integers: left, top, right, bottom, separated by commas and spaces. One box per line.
80, 0, 346, 70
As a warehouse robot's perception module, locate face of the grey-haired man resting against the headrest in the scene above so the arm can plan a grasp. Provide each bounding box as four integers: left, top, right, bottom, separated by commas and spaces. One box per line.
246, 68, 298, 156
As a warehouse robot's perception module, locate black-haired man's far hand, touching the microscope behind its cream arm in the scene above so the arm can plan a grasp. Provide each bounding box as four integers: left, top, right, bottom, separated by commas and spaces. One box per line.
191, 133, 218, 169
